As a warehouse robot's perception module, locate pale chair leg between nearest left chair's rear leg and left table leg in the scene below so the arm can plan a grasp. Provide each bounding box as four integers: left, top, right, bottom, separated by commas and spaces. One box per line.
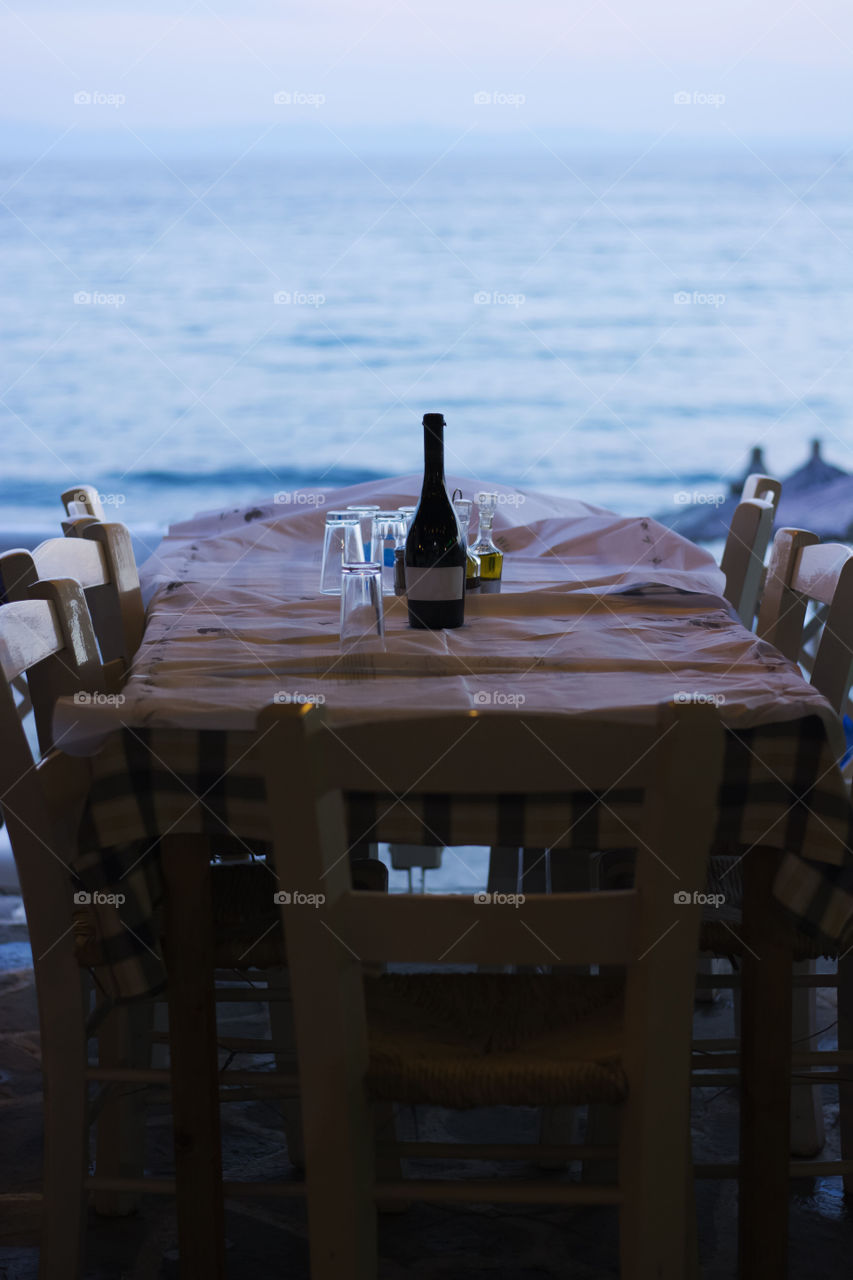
92, 1001, 154, 1217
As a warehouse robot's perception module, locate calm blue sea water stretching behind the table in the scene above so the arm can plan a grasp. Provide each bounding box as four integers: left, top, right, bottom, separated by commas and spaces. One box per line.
0, 142, 853, 529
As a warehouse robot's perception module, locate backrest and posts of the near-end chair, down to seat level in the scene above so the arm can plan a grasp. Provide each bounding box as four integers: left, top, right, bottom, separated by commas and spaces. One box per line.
257, 704, 722, 1157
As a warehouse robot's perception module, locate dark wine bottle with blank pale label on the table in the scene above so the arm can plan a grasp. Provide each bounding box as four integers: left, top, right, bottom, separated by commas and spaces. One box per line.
406, 413, 466, 631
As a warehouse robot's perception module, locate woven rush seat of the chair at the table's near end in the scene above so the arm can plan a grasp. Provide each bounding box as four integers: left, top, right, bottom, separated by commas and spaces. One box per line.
365, 973, 628, 1107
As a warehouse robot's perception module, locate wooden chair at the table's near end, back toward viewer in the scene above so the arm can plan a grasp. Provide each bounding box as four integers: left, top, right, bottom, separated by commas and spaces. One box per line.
259, 707, 722, 1280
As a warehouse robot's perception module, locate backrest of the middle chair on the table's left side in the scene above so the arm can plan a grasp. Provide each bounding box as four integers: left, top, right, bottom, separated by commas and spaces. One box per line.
0, 521, 145, 669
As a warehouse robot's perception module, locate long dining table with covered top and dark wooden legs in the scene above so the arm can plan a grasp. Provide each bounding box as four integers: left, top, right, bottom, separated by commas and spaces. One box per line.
56, 481, 850, 1280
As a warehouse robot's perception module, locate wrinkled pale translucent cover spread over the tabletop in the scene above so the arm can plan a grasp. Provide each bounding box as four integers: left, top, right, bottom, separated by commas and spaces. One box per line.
56, 476, 838, 750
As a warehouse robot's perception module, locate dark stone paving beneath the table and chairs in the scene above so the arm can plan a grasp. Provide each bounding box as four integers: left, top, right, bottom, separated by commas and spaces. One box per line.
0, 896, 853, 1280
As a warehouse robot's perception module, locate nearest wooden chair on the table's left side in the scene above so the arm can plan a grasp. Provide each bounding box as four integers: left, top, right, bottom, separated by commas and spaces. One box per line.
0, 580, 386, 1280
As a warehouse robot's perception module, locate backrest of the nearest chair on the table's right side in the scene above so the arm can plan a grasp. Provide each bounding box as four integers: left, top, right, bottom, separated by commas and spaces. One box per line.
757, 529, 853, 714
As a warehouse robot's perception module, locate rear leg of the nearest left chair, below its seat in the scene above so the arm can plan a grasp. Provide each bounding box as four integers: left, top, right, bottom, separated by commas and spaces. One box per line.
36, 956, 88, 1280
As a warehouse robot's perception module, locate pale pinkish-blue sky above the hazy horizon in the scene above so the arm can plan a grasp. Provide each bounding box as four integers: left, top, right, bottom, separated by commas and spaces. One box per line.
0, 0, 853, 146
